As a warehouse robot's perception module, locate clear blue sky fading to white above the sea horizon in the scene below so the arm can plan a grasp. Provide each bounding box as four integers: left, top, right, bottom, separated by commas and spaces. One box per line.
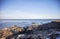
0, 0, 60, 19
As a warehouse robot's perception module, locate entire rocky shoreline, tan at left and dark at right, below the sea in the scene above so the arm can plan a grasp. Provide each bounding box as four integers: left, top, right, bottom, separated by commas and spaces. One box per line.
0, 20, 60, 39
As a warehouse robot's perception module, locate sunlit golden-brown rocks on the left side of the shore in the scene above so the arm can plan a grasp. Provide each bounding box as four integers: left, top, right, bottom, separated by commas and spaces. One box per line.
0, 25, 24, 39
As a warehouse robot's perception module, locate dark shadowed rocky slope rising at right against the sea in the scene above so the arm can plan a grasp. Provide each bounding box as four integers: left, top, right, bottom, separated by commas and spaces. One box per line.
38, 21, 60, 30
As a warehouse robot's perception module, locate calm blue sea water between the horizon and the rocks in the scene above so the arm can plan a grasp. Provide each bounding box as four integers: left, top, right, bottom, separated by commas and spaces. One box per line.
0, 19, 59, 29
